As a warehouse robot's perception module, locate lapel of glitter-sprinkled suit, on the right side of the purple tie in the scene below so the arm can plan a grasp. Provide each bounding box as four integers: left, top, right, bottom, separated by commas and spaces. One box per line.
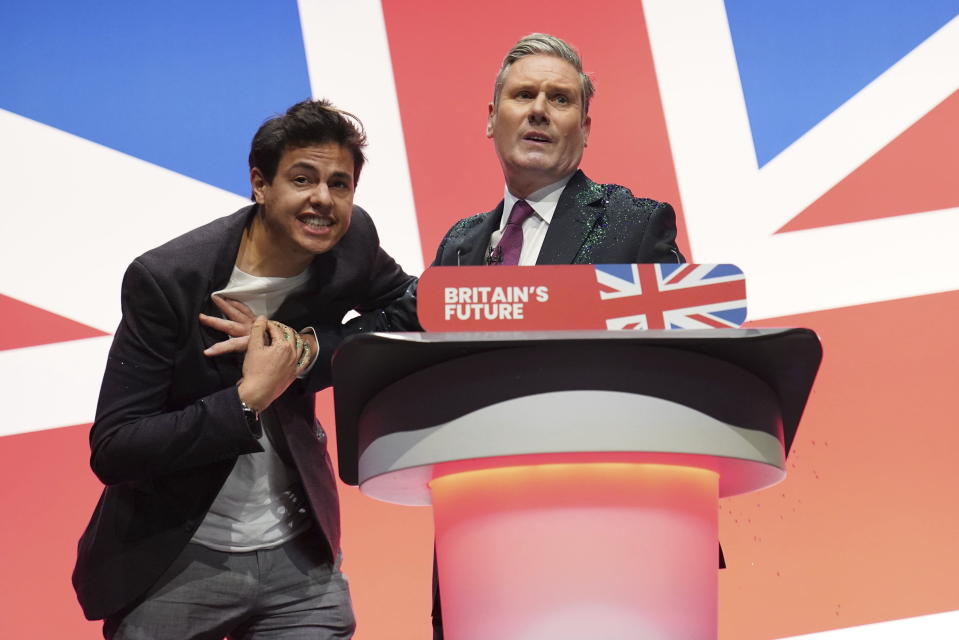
536, 171, 606, 264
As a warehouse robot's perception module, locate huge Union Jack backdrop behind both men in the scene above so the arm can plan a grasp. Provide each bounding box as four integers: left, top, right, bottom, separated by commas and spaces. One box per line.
0, 0, 959, 640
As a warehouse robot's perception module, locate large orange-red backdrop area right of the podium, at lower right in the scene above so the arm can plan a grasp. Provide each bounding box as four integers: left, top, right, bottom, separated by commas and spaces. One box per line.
719, 292, 959, 640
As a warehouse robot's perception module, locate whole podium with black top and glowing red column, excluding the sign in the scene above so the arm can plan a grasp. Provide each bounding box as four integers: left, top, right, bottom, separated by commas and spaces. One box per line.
334, 329, 822, 640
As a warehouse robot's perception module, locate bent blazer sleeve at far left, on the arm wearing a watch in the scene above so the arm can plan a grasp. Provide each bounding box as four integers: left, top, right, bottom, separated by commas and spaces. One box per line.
90, 261, 262, 484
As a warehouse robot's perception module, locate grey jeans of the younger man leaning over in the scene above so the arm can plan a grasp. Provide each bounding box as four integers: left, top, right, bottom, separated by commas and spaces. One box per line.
103, 535, 356, 640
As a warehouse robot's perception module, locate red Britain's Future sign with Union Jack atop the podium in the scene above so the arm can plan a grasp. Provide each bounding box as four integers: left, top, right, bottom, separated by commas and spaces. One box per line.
417, 263, 746, 331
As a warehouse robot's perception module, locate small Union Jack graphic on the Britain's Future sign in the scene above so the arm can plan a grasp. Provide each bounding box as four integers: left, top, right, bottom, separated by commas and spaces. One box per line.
596, 264, 746, 329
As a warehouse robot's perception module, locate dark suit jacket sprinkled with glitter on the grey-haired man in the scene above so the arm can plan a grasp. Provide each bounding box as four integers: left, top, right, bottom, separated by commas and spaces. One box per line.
432, 171, 685, 267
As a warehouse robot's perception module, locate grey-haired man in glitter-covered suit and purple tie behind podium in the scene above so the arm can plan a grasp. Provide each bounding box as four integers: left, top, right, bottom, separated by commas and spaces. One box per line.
433, 33, 685, 639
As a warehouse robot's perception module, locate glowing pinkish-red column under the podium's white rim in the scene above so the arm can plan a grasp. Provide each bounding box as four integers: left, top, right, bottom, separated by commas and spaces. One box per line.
431, 462, 718, 640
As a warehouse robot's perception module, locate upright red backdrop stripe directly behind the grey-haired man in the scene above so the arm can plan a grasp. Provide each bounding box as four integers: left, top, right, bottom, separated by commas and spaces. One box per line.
383, 0, 691, 264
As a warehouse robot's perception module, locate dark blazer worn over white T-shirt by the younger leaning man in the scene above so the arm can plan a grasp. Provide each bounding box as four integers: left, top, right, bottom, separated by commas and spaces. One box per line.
73, 205, 413, 620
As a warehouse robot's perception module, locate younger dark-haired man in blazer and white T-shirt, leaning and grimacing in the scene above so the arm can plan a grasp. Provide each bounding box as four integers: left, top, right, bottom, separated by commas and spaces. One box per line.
73, 101, 413, 640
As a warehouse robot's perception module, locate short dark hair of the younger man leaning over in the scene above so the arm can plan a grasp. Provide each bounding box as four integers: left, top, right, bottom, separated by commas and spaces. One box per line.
250, 100, 366, 199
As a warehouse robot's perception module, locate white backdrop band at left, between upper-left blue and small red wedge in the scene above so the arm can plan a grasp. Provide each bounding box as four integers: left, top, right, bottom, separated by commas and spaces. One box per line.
0, 110, 249, 332
